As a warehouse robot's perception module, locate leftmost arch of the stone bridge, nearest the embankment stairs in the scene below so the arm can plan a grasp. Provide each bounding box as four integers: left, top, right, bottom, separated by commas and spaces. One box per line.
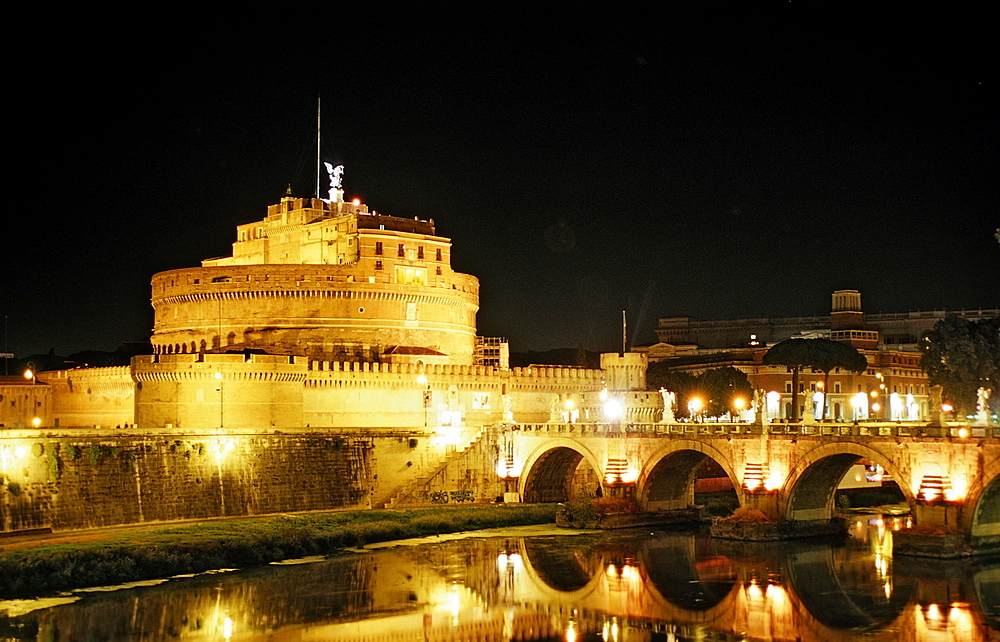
520, 439, 602, 504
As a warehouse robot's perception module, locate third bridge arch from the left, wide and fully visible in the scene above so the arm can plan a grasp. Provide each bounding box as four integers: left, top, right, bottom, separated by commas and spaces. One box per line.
778, 442, 915, 520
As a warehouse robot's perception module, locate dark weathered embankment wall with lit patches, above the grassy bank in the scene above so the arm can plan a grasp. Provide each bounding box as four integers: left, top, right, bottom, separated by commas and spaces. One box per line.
0, 431, 376, 531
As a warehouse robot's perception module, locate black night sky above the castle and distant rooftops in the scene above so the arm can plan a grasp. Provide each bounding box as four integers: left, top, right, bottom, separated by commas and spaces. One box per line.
0, 0, 1000, 356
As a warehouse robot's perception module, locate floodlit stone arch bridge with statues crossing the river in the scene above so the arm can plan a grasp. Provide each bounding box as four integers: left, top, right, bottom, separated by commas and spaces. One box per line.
497, 423, 1000, 545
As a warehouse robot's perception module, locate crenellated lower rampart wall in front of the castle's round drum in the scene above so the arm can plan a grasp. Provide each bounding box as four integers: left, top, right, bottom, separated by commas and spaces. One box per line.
132, 354, 612, 430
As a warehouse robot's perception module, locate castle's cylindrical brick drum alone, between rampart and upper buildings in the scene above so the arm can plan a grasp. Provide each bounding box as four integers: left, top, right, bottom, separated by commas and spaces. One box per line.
152, 265, 479, 362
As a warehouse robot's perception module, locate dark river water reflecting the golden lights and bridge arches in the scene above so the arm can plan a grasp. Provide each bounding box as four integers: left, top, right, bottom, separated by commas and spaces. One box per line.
0, 516, 1000, 642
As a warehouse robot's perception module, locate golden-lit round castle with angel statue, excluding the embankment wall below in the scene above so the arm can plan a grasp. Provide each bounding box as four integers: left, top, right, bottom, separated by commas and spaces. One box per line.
40, 167, 661, 431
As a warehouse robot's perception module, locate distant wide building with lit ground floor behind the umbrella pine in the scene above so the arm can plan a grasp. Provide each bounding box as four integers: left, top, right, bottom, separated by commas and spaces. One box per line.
640, 290, 1000, 421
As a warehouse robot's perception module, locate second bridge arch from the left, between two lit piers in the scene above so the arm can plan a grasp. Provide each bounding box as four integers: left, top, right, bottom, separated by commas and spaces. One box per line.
636, 439, 739, 510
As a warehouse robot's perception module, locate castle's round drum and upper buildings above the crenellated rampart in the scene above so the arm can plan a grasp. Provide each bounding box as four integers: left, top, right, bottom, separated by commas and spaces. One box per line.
151, 197, 479, 364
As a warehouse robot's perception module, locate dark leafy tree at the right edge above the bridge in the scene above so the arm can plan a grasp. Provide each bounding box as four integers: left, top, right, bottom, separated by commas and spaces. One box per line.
920, 314, 1000, 415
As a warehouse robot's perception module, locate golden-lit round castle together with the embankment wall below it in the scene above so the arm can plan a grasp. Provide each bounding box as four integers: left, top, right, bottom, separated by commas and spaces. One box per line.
0, 168, 648, 532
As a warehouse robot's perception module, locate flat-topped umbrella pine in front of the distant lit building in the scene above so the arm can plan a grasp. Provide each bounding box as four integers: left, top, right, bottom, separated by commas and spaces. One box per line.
763, 339, 868, 423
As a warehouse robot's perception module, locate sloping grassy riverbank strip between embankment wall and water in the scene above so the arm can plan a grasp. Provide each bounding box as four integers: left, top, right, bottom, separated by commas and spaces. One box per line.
0, 505, 555, 599
